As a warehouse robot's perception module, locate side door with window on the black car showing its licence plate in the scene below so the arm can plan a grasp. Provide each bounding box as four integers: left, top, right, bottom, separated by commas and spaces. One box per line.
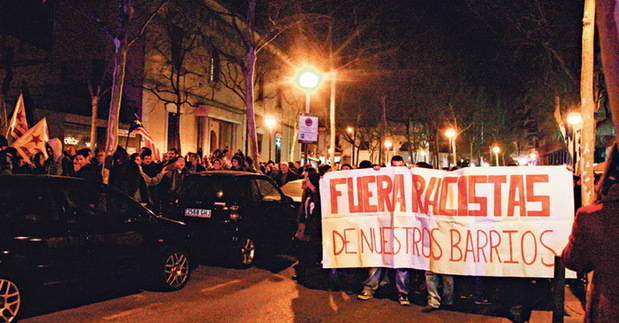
255, 178, 296, 251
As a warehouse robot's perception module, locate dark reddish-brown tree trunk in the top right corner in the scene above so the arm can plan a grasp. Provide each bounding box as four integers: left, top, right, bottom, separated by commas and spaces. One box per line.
600, 0, 619, 147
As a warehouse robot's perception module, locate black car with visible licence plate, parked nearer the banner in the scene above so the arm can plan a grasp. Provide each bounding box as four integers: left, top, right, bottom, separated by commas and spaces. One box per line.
169, 171, 296, 267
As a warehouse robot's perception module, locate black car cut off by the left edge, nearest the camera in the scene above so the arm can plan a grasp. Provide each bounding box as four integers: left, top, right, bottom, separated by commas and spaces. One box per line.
0, 175, 190, 322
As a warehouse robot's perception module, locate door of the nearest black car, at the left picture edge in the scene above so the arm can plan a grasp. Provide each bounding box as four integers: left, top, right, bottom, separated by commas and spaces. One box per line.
0, 177, 86, 294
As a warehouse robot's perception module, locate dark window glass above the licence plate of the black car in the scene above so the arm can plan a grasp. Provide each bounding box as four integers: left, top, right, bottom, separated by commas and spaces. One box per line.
180, 176, 242, 203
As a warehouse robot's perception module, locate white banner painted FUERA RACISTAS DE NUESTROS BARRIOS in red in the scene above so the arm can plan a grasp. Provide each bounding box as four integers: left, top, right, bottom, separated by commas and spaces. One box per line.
320, 166, 574, 278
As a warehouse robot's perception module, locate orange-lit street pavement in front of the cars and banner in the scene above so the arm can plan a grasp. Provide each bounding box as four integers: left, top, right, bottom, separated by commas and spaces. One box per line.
22, 258, 568, 323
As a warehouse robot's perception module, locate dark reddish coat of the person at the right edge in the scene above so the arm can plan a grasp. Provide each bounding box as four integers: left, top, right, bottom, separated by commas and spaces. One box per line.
562, 184, 619, 323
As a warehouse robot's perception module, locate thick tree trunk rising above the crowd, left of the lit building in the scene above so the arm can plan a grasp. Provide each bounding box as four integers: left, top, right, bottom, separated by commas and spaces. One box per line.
105, 38, 128, 155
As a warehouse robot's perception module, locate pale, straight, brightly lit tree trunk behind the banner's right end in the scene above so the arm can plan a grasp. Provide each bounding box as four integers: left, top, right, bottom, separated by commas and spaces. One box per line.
572, 0, 596, 205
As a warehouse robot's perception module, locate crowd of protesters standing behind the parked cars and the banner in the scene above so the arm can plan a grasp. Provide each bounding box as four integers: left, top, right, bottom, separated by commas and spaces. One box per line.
0, 136, 619, 322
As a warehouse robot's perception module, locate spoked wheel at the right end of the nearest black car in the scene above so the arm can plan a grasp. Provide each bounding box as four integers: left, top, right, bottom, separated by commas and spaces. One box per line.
155, 249, 191, 291
